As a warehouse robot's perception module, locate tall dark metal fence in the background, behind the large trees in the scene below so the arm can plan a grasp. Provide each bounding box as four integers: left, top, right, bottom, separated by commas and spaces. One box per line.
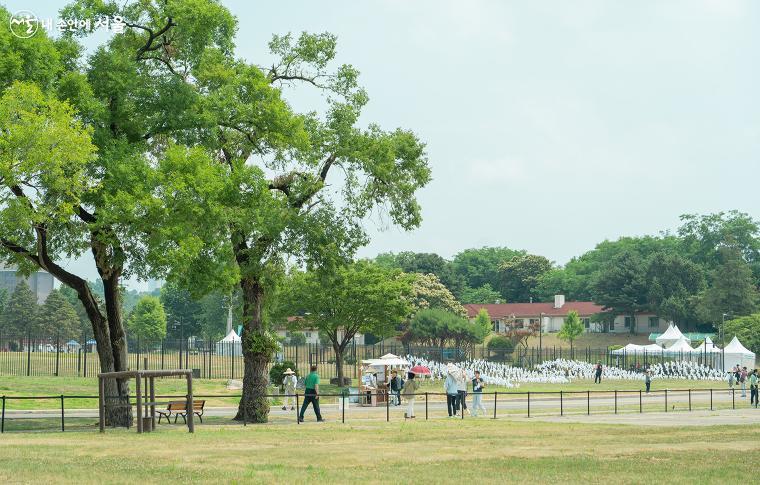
0, 334, 722, 379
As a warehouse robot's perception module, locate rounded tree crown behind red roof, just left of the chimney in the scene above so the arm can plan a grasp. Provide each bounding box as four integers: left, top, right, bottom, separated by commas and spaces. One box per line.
499, 254, 552, 302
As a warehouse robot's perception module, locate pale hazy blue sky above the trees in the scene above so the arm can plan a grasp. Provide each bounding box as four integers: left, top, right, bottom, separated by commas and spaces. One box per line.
0, 0, 760, 288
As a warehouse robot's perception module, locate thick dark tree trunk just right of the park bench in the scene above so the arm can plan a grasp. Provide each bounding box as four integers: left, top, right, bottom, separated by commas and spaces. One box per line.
235, 277, 271, 423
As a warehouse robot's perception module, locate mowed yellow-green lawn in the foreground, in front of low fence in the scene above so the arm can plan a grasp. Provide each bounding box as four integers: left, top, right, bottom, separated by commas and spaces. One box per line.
0, 420, 760, 483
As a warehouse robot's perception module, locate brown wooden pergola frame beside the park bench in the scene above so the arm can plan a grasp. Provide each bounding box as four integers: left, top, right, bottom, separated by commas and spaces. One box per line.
98, 369, 195, 433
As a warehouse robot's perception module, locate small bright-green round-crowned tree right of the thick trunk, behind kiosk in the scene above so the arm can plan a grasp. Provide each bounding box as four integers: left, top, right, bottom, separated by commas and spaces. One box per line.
280, 261, 411, 385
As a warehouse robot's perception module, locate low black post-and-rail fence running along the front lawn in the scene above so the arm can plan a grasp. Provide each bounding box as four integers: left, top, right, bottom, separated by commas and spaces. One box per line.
0, 388, 757, 433
